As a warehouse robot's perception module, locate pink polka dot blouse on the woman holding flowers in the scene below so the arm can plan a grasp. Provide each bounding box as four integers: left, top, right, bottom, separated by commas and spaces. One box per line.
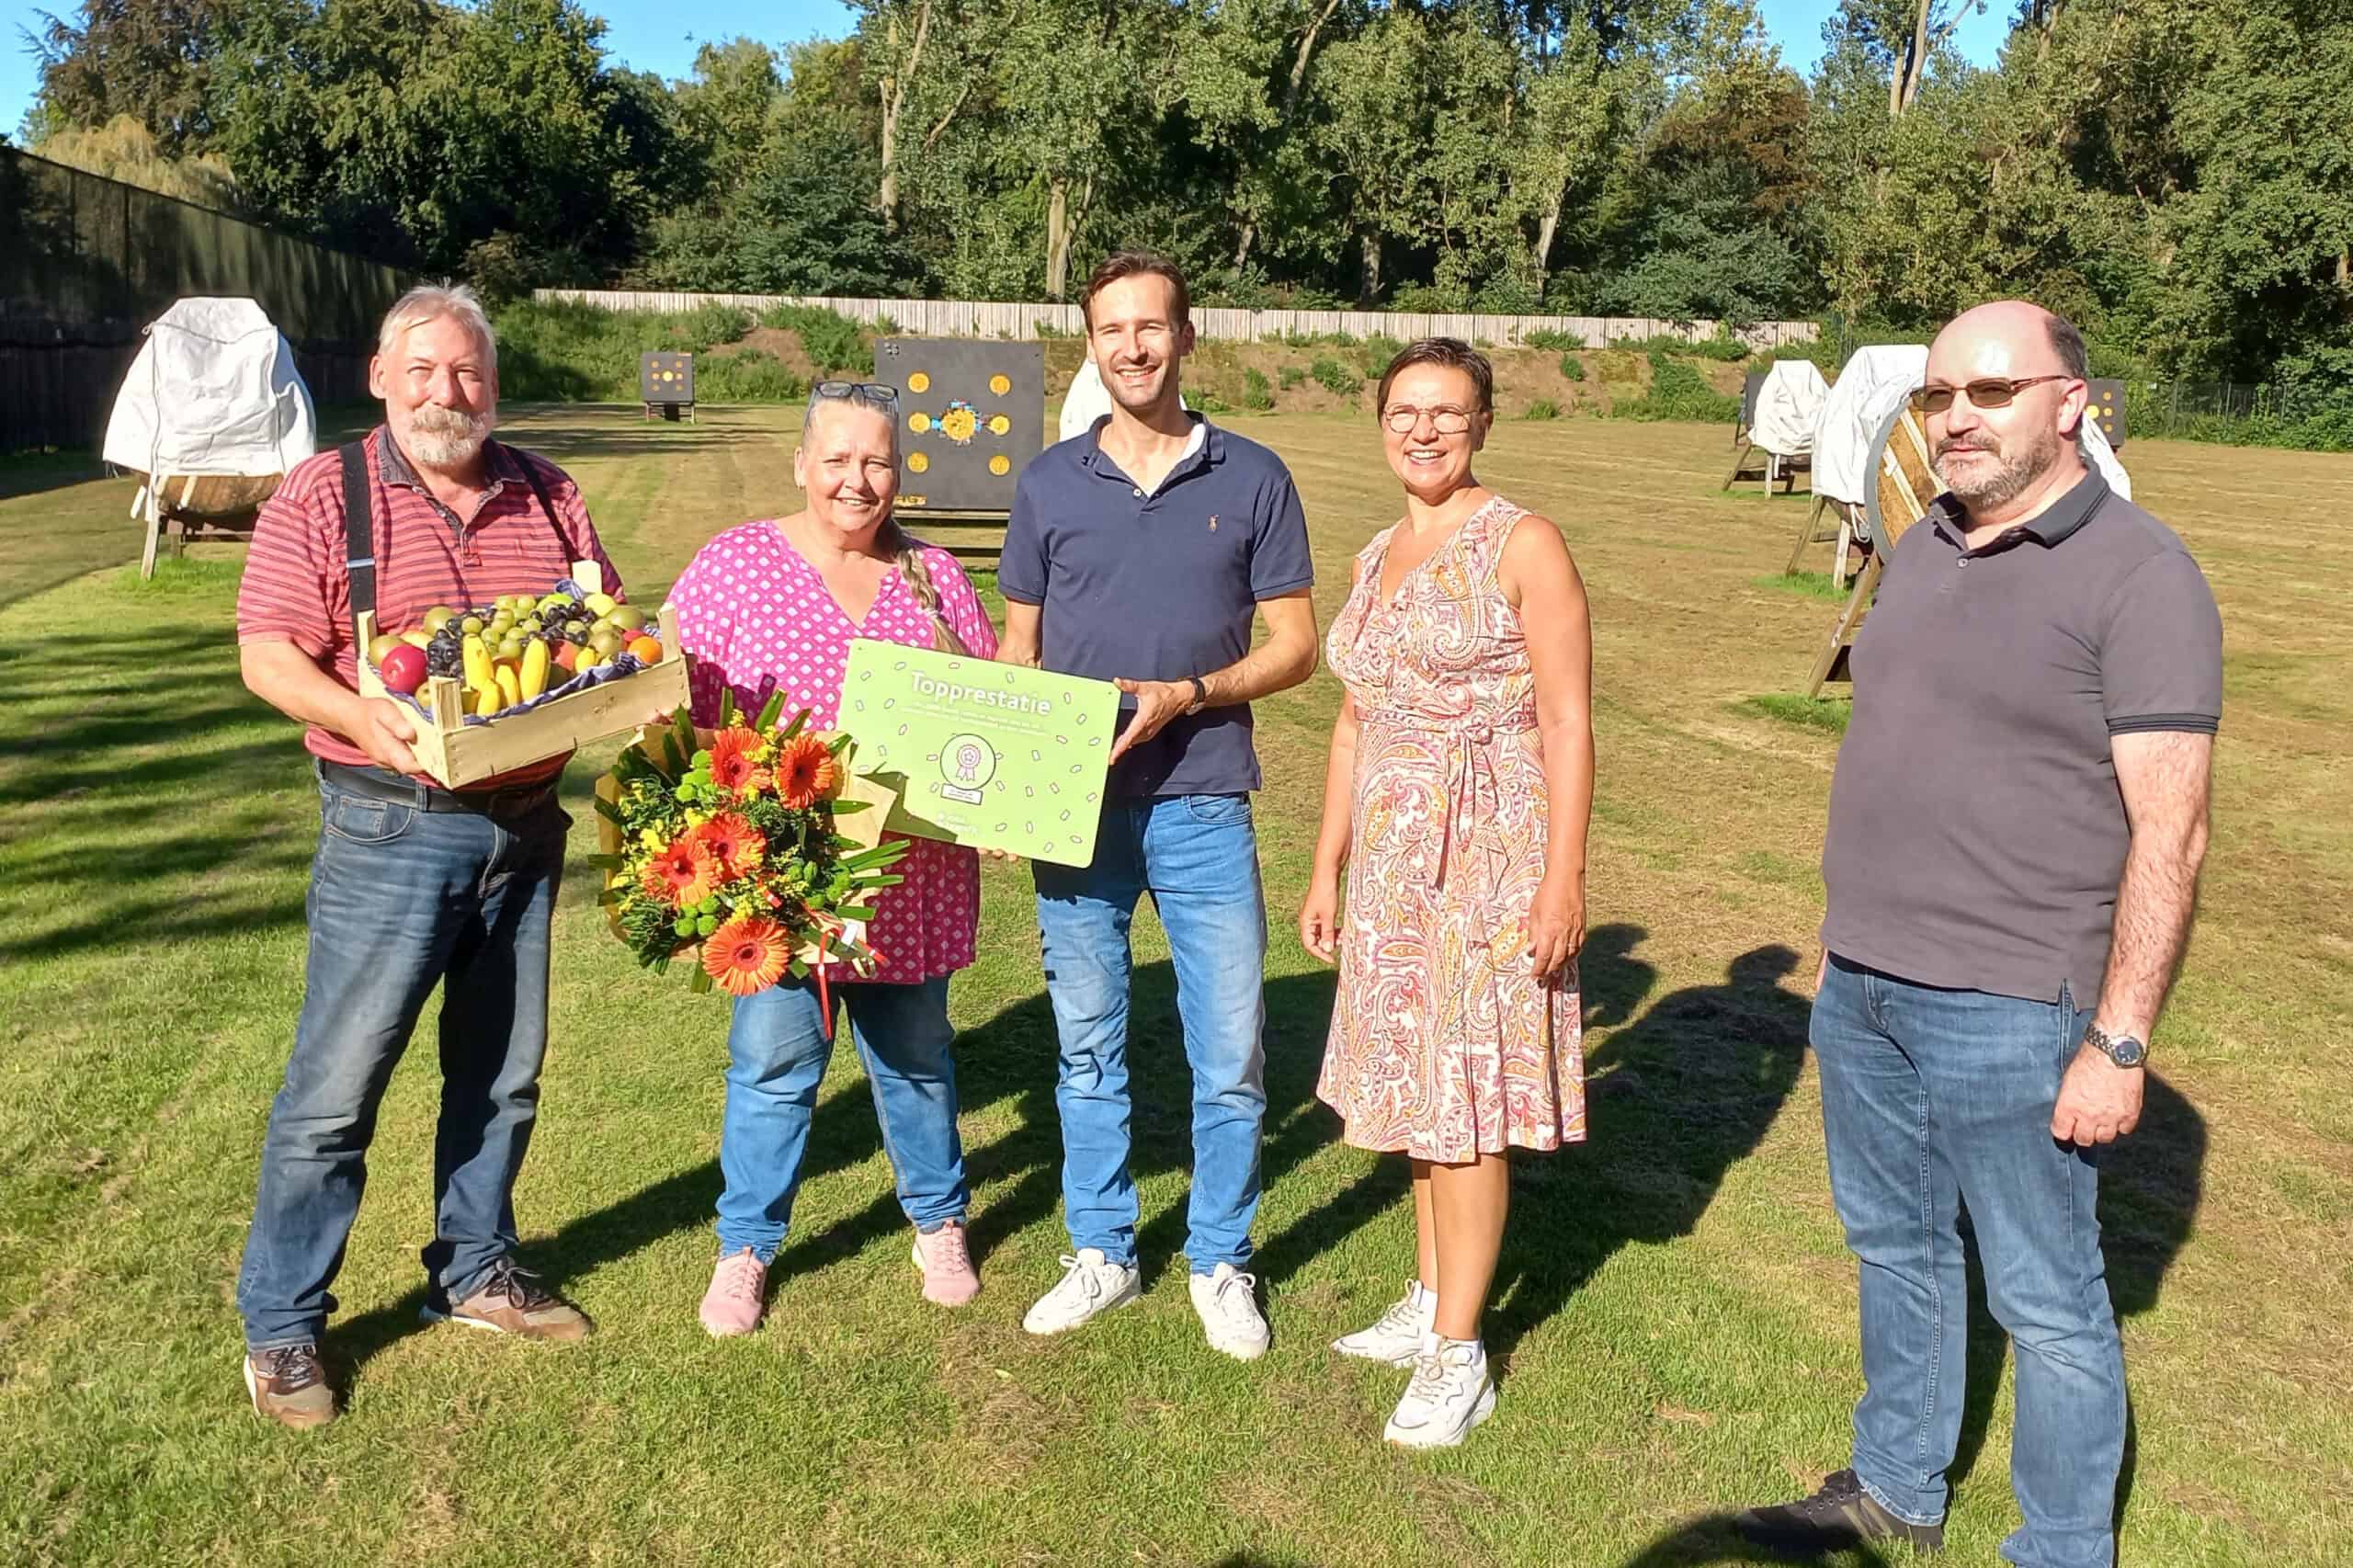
671, 520, 997, 984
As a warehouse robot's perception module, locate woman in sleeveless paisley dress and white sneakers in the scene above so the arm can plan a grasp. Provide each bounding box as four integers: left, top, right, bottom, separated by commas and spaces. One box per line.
1299, 336, 1593, 1448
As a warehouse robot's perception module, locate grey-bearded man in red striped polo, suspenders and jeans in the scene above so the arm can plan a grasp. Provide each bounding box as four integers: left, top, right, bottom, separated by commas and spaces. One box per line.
238, 288, 621, 1426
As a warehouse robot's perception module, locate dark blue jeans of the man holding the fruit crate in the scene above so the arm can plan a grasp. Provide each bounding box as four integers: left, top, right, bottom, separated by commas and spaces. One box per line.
238, 779, 572, 1351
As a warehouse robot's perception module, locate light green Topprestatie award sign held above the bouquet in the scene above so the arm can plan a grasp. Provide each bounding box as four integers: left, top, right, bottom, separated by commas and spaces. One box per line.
837, 638, 1120, 867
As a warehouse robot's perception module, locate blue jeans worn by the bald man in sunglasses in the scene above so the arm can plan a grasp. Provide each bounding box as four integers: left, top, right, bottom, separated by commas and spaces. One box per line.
1812, 953, 2125, 1568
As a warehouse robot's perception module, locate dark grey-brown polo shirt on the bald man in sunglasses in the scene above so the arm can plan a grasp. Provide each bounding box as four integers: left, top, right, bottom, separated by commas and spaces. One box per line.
1821, 473, 2222, 1007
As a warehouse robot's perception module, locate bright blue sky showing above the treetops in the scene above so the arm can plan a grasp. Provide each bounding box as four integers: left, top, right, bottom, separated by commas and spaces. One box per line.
0, 0, 2014, 149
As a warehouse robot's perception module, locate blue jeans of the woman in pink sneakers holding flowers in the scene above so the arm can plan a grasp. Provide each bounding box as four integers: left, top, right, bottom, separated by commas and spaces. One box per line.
720, 974, 967, 1265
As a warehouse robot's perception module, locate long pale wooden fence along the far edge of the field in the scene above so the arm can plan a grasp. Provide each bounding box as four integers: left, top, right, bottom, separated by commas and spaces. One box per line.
534, 290, 1821, 348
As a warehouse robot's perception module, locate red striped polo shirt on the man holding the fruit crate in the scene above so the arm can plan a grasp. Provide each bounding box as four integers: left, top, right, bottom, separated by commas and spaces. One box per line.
238, 426, 621, 789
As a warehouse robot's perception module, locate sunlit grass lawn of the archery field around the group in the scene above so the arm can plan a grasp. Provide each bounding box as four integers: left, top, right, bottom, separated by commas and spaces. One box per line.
0, 407, 2353, 1568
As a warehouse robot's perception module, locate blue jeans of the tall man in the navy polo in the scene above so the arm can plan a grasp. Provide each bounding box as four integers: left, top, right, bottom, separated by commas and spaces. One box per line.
1035, 796, 1266, 1274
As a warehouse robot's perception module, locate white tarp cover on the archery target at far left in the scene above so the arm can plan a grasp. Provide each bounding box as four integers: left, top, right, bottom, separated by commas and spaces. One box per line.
104, 299, 318, 478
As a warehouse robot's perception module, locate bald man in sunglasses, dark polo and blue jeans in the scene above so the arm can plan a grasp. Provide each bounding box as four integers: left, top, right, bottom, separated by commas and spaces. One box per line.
1734, 301, 2222, 1568
